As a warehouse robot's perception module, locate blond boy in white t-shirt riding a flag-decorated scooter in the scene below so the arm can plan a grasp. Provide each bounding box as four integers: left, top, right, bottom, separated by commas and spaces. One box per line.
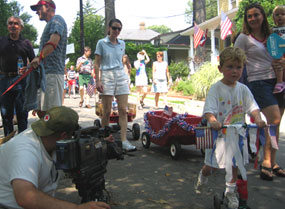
194, 47, 265, 208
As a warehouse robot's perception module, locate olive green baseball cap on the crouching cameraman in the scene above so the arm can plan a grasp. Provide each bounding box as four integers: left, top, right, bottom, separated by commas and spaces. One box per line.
31, 106, 79, 136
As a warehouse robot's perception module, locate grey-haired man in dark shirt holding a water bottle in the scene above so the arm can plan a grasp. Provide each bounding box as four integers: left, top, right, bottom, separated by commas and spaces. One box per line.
0, 16, 35, 136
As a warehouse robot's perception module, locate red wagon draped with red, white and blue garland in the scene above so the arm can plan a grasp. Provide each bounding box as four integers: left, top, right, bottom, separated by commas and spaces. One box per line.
141, 111, 202, 159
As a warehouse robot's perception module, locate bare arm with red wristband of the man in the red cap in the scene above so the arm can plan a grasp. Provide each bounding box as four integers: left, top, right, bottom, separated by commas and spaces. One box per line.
31, 33, 60, 68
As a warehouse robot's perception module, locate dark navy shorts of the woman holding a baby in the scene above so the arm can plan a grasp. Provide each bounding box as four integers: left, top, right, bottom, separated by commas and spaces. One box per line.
248, 79, 284, 110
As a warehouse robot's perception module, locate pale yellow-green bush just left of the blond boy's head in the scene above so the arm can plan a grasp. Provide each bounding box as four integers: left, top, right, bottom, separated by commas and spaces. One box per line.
190, 62, 222, 99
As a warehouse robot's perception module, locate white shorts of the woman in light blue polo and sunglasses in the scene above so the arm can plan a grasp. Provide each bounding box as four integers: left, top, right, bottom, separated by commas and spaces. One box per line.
101, 70, 130, 96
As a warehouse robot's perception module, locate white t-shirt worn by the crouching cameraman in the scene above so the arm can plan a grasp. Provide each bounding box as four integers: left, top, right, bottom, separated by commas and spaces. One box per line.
0, 128, 59, 208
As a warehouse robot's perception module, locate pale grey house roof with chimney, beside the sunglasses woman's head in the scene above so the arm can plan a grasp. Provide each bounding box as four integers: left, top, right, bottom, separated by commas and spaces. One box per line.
118, 29, 160, 41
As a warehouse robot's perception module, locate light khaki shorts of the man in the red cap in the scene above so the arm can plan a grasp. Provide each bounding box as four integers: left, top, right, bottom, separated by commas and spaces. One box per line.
38, 74, 64, 111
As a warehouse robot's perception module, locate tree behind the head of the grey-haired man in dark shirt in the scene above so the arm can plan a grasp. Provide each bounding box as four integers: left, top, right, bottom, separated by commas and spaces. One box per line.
0, 0, 38, 44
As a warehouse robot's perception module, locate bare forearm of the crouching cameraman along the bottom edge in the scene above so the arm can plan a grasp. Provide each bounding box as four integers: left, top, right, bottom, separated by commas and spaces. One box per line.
12, 179, 110, 209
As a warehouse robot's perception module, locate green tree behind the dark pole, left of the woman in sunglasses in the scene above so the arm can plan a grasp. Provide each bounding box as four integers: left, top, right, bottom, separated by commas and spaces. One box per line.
67, 3, 105, 65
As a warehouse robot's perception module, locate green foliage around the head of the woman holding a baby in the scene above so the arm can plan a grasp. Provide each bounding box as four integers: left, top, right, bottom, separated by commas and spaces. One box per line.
234, 0, 284, 31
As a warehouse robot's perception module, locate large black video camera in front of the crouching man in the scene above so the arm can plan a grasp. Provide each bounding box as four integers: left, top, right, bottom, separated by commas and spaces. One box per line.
56, 126, 123, 203
